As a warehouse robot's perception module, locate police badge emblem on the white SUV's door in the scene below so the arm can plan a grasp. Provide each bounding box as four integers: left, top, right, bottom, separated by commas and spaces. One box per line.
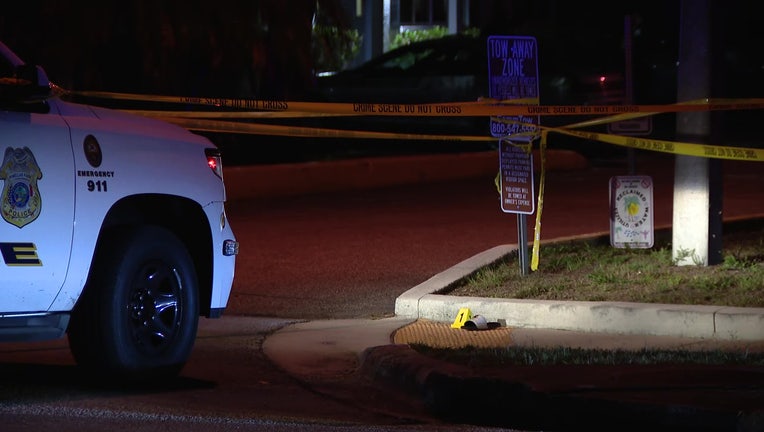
0, 147, 42, 228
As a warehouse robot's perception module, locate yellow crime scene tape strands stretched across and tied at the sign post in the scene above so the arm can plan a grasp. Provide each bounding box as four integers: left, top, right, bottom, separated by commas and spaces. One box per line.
65, 91, 764, 271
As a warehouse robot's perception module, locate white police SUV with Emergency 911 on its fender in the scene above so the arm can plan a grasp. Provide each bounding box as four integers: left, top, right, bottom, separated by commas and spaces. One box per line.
0, 43, 238, 379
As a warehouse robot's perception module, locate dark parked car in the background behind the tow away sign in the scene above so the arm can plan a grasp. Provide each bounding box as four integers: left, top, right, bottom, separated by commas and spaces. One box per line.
317, 35, 624, 139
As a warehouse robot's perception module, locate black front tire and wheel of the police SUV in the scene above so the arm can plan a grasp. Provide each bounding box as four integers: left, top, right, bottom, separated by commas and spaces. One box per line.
69, 226, 199, 382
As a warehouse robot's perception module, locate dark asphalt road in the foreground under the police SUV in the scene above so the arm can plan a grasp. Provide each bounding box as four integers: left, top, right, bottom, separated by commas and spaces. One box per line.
0, 316, 478, 432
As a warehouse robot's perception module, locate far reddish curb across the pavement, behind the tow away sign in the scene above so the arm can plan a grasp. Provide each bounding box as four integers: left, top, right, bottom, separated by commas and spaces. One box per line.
223, 150, 588, 201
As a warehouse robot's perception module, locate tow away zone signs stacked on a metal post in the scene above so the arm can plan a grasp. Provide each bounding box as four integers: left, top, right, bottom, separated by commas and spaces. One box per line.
488, 36, 539, 275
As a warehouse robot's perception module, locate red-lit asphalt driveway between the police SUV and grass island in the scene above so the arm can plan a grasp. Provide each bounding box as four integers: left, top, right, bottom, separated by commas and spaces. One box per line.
226, 154, 764, 319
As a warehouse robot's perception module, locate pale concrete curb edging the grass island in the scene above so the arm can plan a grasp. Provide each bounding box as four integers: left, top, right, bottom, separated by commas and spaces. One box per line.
395, 228, 764, 341
